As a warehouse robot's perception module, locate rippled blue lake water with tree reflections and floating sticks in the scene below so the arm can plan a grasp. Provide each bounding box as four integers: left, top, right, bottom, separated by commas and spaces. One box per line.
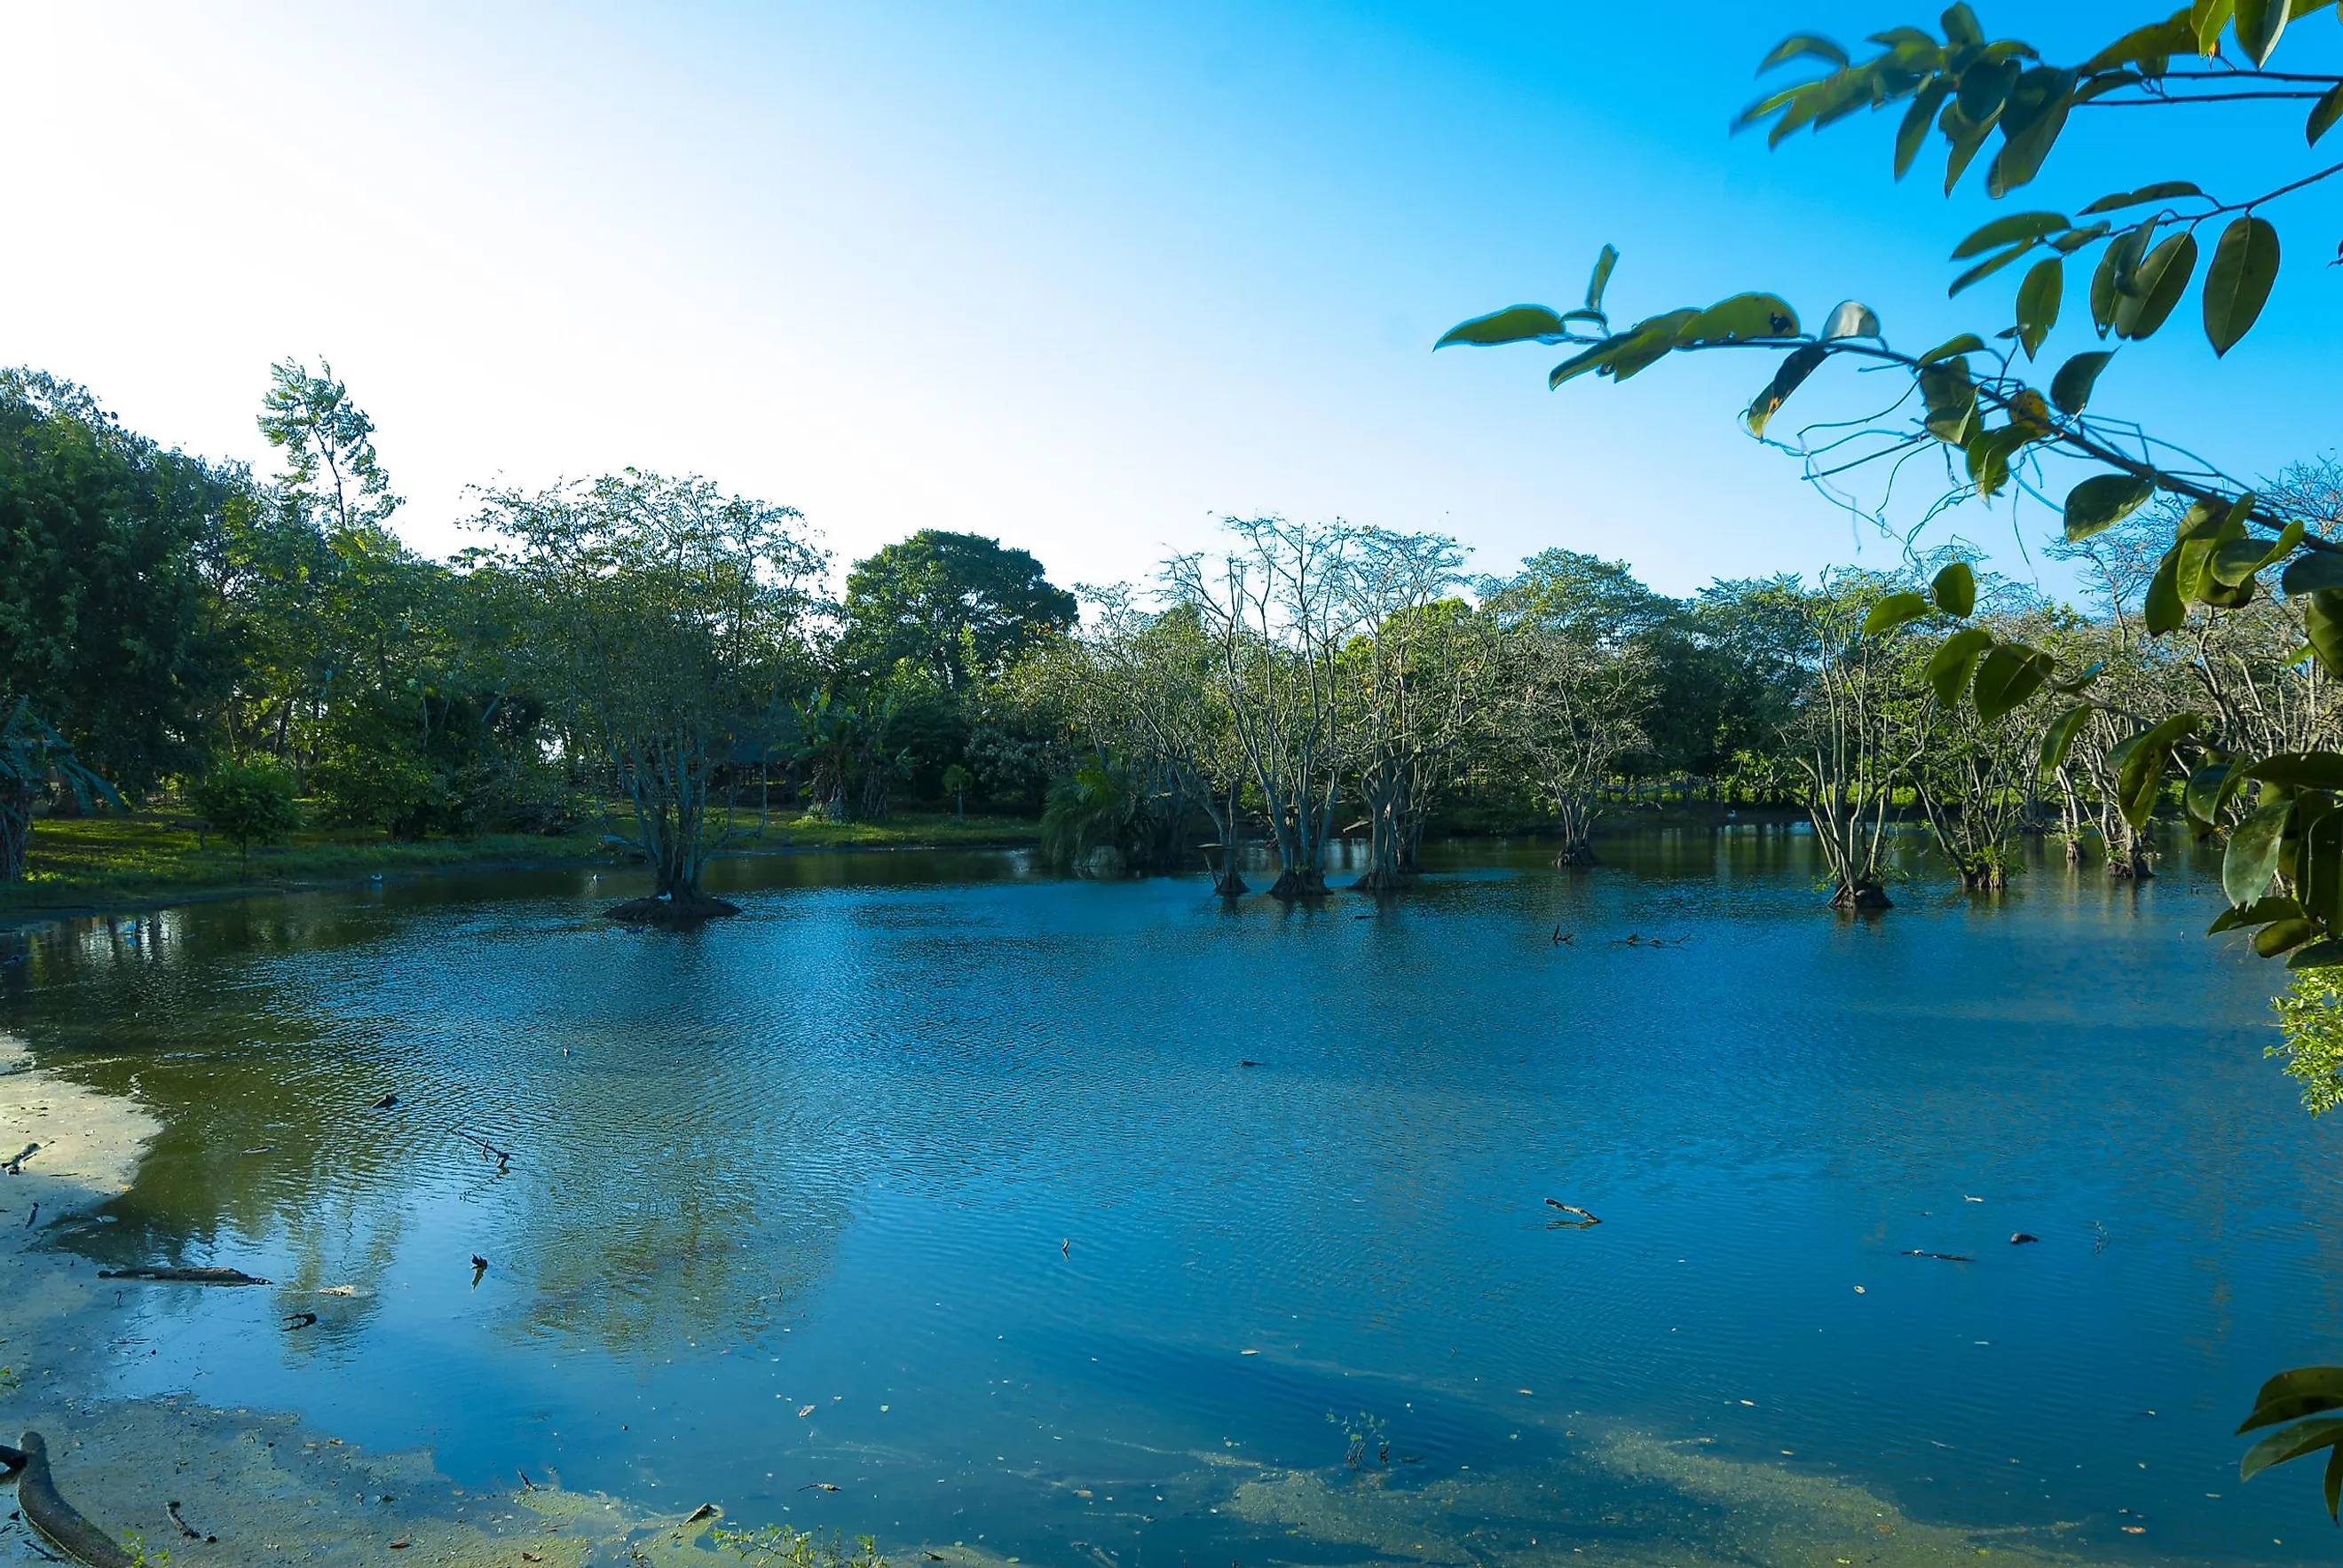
0, 827, 2343, 1568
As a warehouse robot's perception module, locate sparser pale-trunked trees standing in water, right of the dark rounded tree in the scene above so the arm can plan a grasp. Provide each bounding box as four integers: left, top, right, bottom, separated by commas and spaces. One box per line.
1012, 490, 2343, 907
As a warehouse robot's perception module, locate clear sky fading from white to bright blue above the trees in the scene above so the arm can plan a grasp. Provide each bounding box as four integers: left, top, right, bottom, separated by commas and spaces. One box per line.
0, 0, 2343, 593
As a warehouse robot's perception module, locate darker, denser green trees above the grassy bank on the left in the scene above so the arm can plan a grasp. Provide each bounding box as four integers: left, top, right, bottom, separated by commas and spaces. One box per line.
0, 363, 1076, 900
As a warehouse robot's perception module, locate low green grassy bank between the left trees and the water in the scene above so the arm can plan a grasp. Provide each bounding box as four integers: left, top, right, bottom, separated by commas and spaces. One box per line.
0, 811, 1038, 917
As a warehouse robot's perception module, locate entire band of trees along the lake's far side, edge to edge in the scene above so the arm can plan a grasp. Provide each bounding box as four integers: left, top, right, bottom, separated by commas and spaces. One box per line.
13, 363, 2343, 911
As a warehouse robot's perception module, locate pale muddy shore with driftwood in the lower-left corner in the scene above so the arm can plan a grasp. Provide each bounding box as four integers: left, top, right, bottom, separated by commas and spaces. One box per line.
0, 1034, 773, 1568
